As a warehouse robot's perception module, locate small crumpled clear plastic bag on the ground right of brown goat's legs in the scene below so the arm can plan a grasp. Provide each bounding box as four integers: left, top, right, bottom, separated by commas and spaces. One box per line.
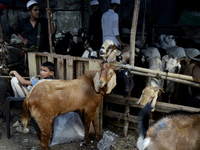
97, 131, 119, 150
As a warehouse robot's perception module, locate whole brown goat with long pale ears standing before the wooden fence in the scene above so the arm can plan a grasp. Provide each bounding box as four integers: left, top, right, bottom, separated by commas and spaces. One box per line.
22, 64, 116, 150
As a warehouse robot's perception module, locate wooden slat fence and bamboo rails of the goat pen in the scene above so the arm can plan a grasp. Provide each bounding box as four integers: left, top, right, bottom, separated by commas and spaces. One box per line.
28, 52, 200, 135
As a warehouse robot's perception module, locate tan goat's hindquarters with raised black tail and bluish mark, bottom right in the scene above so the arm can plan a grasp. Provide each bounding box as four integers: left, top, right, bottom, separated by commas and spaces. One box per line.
137, 103, 200, 150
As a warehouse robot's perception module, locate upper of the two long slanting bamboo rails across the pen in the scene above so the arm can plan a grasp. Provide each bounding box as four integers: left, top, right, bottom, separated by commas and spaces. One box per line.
110, 63, 194, 81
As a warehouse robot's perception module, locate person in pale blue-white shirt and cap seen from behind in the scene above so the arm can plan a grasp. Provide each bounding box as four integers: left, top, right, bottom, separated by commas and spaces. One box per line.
101, 0, 128, 47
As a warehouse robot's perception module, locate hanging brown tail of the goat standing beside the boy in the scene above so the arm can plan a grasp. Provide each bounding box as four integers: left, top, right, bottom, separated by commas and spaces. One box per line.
22, 98, 31, 128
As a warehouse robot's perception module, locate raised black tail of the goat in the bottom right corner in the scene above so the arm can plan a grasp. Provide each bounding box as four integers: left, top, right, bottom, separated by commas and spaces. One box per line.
138, 103, 153, 138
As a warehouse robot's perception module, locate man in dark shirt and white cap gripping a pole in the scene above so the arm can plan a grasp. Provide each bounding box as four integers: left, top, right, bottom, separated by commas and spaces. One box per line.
15, 0, 55, 52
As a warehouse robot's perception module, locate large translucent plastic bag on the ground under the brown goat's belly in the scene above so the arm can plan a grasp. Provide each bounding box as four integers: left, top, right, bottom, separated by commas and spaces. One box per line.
50, 112, 85, 146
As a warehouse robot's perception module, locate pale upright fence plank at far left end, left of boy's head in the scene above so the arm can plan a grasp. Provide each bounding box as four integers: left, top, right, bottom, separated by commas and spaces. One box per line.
28, 53, 37, 78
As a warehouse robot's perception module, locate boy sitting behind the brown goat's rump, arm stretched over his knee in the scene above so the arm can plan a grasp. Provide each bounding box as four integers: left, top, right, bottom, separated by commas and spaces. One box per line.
9, 61, 55, 97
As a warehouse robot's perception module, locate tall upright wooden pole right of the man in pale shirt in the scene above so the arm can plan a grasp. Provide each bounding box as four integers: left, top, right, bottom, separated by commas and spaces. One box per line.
124, 0, 140, 136
